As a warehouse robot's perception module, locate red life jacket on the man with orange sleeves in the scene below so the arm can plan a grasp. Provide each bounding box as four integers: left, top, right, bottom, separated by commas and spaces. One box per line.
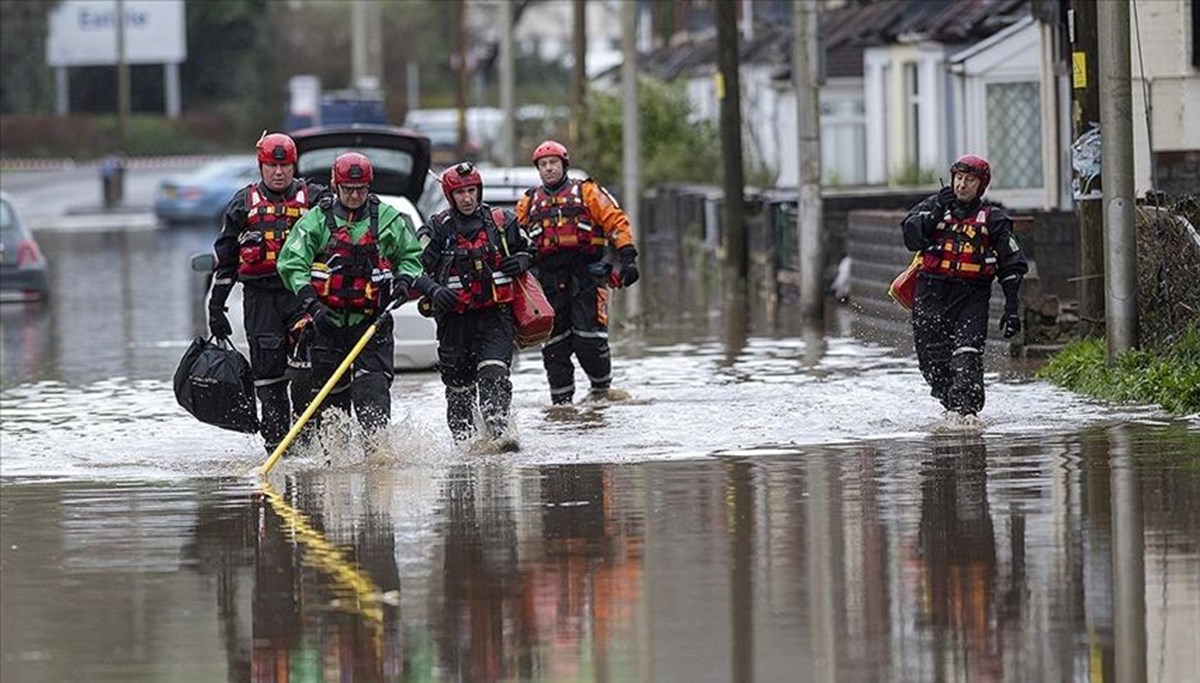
527, 179, 606, 256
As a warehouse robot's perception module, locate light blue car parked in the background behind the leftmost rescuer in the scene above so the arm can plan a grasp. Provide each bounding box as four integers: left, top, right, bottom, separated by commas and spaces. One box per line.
154, 156, 260, 226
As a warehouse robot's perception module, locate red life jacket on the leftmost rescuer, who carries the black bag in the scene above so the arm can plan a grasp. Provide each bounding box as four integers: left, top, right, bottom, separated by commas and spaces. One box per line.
238, 182, 308, 278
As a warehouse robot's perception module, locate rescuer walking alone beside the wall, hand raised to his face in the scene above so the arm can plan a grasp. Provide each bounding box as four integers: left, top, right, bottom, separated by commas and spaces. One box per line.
901, 154, 1028, 415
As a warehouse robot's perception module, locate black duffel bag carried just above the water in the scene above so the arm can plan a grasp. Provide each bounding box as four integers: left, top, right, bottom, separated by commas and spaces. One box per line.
175, 337, 258, 432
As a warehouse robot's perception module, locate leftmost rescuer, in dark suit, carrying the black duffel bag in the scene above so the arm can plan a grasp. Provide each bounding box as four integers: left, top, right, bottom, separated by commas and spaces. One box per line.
209, 132, 329, 453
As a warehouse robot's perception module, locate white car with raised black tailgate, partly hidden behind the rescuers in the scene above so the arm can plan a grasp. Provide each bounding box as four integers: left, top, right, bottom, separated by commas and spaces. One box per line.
192, 124, 438, 370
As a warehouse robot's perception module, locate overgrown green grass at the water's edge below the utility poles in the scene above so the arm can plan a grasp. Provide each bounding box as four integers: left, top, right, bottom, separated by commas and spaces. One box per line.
1038, 324, 1200, 415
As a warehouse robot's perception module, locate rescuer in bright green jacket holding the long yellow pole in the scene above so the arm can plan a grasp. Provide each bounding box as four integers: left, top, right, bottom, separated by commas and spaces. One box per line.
278, 151, 421, 435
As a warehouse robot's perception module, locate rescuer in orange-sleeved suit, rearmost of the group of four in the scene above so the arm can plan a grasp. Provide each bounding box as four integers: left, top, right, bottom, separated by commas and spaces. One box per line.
516, 140, 638, 405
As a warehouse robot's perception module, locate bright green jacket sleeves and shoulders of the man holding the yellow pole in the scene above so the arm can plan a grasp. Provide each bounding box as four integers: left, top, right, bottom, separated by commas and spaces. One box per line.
276, 195, 422, 325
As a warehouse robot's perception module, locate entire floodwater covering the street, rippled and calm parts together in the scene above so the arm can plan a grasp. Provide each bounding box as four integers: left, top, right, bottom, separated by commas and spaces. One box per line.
0, 177, 1200, 683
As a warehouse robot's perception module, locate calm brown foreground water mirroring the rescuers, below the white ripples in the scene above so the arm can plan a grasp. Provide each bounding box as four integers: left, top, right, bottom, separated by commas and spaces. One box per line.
0, 425, 1200, 682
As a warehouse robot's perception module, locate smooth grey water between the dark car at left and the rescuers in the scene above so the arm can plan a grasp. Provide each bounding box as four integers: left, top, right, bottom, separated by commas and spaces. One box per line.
0, 222, 212, 388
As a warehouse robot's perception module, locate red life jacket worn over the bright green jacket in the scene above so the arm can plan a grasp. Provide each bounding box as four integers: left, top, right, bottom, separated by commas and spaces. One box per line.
312, 197, 392, 316
